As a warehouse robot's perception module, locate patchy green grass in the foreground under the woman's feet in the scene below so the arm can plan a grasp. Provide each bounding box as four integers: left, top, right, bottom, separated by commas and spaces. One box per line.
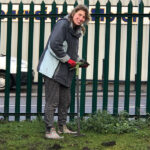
0, 113, 150, 150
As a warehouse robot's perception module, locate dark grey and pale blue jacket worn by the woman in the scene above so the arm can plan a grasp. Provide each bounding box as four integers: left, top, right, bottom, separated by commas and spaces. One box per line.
38, 17, 81, 87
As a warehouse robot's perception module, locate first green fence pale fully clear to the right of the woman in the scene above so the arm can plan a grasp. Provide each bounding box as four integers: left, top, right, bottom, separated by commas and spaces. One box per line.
92, 1, 100, 113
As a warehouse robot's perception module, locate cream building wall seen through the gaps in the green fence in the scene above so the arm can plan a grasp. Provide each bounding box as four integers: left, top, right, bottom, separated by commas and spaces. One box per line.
0, 0, 150, 81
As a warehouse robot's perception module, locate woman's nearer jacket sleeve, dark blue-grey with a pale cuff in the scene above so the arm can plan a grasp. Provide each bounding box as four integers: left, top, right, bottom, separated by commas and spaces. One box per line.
50, 20, 70, 63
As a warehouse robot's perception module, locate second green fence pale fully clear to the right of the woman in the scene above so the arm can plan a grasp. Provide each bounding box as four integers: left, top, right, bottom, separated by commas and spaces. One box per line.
103, 1, 111, 110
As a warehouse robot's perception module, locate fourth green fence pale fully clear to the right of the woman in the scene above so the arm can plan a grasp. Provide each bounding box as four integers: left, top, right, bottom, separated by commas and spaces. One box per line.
124, 1, 133, 112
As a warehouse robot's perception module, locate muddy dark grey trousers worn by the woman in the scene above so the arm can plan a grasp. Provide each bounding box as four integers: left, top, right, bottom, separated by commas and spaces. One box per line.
44, 77, 70, 128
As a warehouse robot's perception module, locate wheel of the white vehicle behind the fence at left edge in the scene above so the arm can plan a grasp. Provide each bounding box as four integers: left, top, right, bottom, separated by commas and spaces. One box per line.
0, 72, 13, 91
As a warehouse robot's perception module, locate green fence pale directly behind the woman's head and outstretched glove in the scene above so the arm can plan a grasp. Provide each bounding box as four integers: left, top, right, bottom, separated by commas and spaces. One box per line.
80, 0, 89, 117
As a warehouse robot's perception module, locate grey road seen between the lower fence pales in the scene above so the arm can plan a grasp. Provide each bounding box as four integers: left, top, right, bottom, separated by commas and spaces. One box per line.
0, 84, 146, 120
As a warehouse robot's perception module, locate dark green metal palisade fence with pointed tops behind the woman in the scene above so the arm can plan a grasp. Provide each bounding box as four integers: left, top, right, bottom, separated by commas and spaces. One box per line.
0, 0, 150, 120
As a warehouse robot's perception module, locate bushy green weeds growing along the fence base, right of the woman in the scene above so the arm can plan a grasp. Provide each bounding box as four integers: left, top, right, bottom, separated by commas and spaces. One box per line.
69, 111, 150, 134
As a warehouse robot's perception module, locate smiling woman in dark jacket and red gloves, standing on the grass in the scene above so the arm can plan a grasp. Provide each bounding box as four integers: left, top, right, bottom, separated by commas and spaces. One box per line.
38, 5, 89, 139
